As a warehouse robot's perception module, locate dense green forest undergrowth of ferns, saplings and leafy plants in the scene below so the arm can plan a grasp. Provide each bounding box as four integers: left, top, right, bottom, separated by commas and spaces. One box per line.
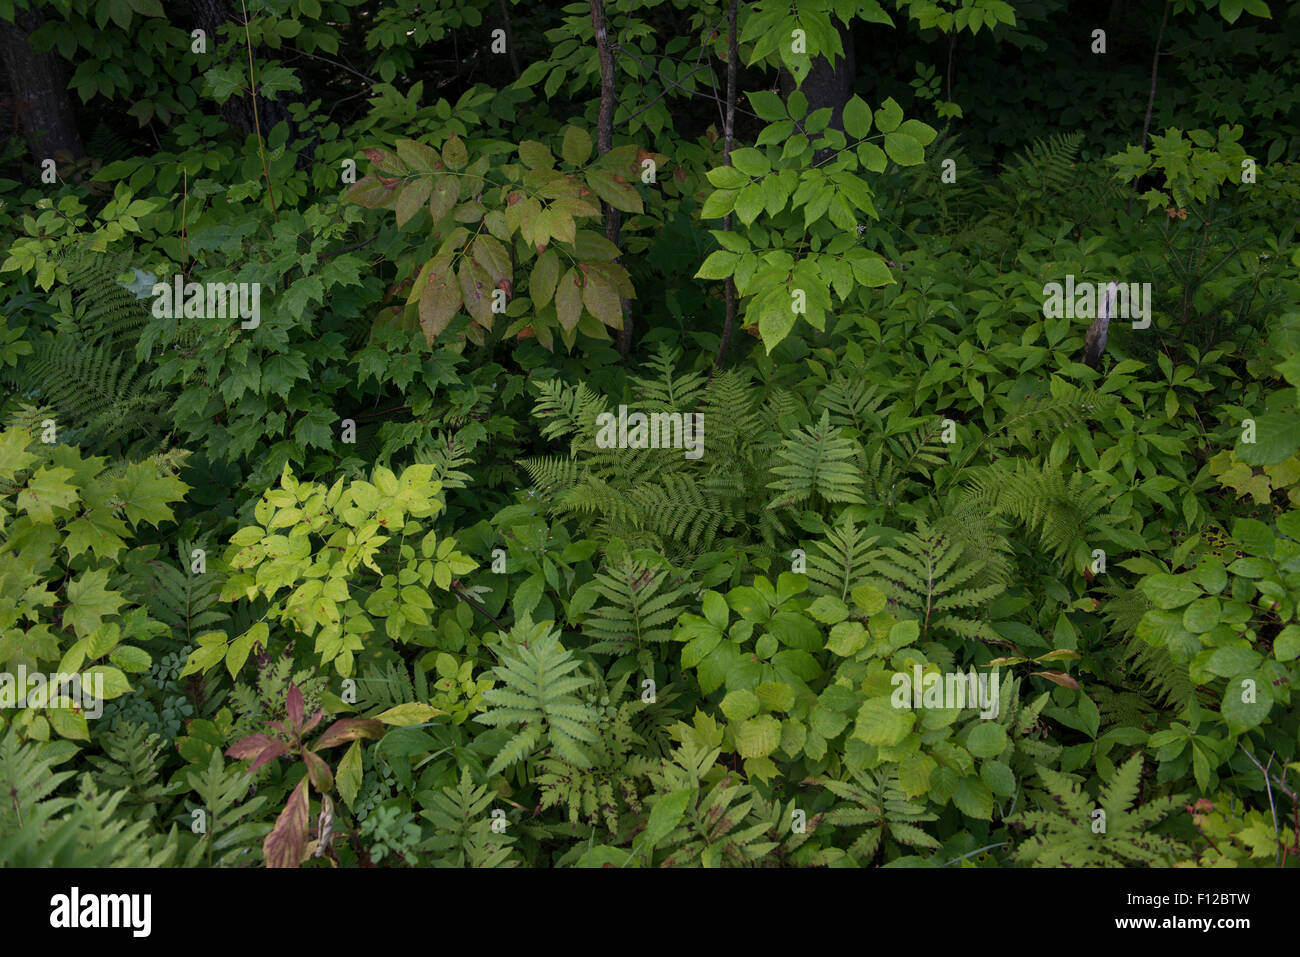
0, 0, 1300, 867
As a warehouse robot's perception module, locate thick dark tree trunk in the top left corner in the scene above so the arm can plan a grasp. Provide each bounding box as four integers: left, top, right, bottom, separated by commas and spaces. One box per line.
0, 10, 86, 163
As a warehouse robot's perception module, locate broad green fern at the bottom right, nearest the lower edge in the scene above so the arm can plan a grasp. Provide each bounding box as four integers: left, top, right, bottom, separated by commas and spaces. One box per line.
1008, 754, 1188, 867
